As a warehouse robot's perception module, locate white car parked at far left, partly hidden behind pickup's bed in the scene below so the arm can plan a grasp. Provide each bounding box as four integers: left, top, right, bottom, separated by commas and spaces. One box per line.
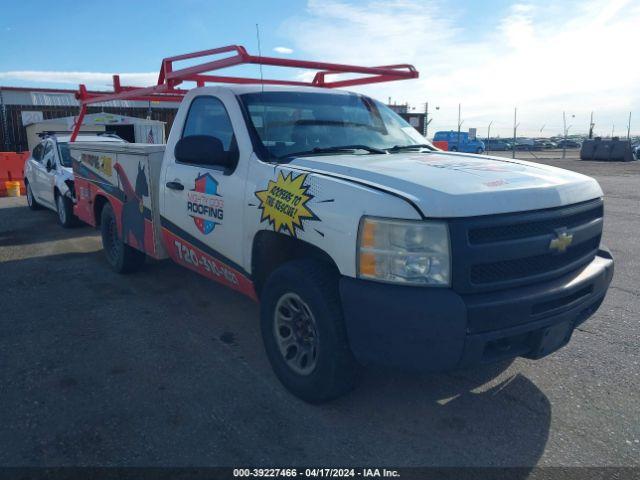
24, 133, 126, 227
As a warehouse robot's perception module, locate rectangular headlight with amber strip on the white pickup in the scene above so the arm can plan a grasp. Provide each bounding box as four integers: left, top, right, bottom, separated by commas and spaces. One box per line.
358, 217, 451, 286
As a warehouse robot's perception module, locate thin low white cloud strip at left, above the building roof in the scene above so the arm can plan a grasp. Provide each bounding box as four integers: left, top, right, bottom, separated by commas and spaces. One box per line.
0, 70, 158, 89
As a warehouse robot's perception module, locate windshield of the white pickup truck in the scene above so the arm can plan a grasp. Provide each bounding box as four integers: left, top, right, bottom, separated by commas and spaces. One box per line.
240, 92, 431, 159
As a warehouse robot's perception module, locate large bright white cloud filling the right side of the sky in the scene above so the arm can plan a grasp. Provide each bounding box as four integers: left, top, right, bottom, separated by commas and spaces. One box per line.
281, 0, 640, 135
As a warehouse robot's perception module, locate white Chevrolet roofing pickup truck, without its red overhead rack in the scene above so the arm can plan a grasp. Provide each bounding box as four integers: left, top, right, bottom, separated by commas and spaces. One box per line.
70, 85, 613, 402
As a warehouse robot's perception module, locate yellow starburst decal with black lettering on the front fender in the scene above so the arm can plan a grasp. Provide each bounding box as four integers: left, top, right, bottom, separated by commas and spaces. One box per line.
255, 171, 319, 237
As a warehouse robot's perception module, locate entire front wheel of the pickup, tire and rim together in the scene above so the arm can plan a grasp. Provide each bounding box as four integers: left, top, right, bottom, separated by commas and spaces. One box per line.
260, 260, 358, 403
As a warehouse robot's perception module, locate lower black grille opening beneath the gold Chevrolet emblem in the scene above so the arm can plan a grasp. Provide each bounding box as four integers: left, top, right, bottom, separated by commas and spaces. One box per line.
471, 237, 600, 285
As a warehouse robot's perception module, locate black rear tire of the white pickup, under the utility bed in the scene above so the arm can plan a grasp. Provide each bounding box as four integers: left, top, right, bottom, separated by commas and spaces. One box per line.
100, 203, 145, 273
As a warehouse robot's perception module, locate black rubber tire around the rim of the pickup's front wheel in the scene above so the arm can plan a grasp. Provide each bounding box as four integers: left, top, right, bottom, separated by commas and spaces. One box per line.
260, 260, 358, 403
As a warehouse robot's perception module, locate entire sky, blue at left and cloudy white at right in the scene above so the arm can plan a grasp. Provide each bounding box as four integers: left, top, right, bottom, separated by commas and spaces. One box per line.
0, 0, 640, 136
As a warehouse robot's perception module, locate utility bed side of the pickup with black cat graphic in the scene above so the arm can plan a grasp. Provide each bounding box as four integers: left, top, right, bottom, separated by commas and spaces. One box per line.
70, 142, 167, 259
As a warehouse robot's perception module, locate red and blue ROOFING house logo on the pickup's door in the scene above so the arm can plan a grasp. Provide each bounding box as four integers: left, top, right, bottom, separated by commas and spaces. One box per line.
187, 173, 224, 235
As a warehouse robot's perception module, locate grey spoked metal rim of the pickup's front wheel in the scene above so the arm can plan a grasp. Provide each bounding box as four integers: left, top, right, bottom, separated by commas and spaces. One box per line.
273, 292, 319, 375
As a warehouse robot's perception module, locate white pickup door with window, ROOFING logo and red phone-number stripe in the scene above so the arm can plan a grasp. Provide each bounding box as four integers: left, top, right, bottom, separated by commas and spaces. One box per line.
161, 95, 253, 295
